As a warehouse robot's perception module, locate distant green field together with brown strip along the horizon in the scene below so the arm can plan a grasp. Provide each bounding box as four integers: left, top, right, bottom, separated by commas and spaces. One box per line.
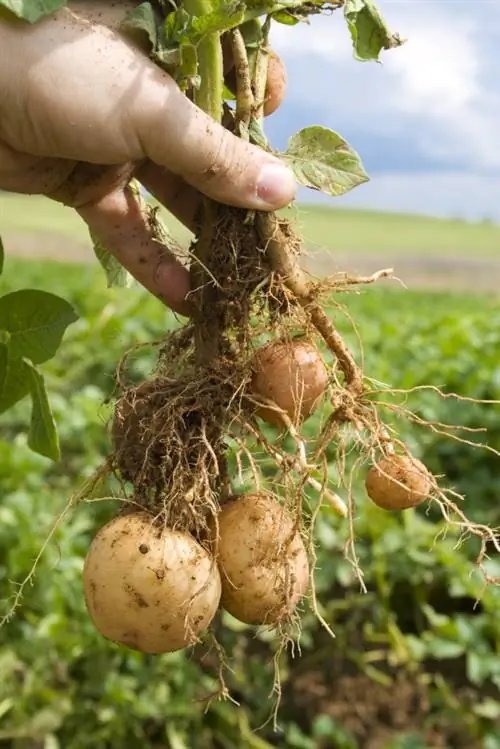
0, 194, 500, 291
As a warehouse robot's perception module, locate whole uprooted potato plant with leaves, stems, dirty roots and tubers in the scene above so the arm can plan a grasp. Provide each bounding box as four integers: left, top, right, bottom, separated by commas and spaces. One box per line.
1, 0, 500, 720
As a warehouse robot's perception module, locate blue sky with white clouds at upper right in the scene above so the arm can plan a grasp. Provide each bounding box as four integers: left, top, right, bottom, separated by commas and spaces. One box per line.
266, 0, 500, 222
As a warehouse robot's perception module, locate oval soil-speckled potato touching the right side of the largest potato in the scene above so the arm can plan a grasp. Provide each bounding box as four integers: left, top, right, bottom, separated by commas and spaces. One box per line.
217, 493, 309, 625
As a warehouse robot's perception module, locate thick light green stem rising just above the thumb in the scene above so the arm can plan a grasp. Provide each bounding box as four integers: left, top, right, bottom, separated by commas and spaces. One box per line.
184, 0, 224, 122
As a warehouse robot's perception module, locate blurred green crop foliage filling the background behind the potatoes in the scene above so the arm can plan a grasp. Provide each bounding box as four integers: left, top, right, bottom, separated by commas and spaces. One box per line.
0, 260, 500, 749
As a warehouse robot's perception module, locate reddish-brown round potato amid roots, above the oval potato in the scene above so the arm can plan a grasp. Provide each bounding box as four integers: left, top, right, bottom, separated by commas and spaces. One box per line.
250, 339, 328, 426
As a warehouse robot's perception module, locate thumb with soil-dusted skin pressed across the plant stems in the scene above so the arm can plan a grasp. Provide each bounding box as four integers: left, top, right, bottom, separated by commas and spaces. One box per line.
133, 69, 297, 211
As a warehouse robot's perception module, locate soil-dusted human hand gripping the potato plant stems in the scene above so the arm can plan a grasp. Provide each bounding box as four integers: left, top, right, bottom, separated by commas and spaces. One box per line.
0, 0, 296, 314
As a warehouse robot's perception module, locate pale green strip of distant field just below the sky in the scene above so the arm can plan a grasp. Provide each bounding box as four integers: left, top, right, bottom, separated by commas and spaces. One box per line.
0, 193, 500, 258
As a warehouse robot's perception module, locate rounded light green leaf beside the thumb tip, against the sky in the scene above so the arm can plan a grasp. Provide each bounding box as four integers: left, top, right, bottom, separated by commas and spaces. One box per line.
281, 125, 369, 196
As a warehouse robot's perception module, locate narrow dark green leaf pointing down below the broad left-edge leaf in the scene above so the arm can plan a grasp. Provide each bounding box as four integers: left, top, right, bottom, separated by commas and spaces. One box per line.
24, 359, 61, 460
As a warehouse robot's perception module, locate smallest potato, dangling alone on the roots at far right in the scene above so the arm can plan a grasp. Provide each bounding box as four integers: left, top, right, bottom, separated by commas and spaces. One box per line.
366, 455, 432, 510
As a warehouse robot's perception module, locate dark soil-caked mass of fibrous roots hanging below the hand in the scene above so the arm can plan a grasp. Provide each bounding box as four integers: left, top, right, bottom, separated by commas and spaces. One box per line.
111, 202, 302, 537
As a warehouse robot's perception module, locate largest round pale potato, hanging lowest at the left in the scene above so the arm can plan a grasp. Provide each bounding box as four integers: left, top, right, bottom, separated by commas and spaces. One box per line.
83, 512, 221, 653
